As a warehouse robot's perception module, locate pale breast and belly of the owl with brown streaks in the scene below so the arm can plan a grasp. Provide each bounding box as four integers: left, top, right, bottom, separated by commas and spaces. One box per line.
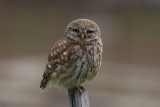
57, 40, 102, 88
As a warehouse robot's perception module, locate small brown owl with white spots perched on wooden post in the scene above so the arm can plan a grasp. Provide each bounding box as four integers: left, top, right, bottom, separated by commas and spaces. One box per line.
40, 19, 103, 89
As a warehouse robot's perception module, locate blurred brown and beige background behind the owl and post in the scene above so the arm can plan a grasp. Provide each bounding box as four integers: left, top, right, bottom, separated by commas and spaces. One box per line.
0, 0, 160, 107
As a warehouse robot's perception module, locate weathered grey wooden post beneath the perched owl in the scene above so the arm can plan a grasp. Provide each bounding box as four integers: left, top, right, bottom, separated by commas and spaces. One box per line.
68, 88, 90, 107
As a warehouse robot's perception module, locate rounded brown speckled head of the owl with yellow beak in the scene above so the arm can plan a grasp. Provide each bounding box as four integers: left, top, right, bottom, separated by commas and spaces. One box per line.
65, 19, 100, 43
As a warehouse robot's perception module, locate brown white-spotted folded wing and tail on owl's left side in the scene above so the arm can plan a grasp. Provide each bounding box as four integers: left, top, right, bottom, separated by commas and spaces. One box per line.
40, 39, 70, 89
